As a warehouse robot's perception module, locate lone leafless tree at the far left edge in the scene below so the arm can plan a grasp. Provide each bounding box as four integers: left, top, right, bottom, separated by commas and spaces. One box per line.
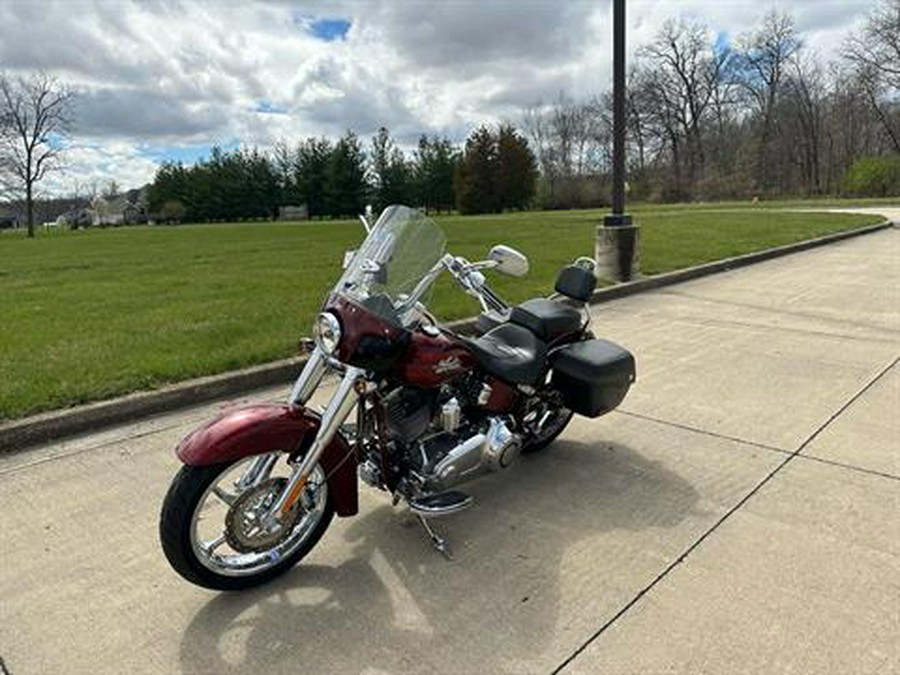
0, 73, 73, 237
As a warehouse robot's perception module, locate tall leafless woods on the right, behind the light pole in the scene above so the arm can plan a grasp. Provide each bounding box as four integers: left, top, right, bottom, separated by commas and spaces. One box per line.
522, 0, 900, 208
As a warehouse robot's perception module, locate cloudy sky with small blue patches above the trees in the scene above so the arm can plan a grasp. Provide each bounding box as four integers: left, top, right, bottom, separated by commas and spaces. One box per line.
0, 0, 873, 191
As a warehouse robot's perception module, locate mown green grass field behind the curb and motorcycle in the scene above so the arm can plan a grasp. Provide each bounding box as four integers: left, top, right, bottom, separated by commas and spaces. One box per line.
0, 205, 879, 420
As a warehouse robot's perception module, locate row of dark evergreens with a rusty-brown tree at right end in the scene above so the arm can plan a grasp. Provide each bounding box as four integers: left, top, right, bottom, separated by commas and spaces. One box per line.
149, 124, 537, 222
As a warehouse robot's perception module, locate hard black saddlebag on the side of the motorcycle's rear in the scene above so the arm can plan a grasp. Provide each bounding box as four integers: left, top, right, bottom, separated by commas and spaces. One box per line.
550, 340, 635, 417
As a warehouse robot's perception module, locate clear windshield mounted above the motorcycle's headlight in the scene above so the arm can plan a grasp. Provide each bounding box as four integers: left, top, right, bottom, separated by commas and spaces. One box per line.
334, 206, 446, 323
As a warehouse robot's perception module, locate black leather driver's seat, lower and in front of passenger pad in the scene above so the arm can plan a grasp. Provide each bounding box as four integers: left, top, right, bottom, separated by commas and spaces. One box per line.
465, 323, 547, 384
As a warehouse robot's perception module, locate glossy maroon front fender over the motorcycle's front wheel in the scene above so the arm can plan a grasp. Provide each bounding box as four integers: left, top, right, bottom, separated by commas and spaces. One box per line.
175, 404, 359, 516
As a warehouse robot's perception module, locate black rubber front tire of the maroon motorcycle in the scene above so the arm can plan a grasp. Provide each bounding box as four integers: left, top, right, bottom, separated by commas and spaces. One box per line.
159, 461, 334, 591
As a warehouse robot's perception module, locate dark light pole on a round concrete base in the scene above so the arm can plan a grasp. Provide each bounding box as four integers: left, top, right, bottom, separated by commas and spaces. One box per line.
596, 0, 639, 281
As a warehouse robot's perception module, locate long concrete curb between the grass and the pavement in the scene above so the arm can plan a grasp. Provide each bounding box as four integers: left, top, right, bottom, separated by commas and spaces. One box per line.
0, 220, 894, 456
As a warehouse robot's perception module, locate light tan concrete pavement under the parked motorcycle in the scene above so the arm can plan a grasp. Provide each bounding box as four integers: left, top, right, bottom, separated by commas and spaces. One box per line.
0, 229, 900, 675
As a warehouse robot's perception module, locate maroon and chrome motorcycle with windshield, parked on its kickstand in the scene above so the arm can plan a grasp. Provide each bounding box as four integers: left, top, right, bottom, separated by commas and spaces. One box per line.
159, 206, 635, 590
